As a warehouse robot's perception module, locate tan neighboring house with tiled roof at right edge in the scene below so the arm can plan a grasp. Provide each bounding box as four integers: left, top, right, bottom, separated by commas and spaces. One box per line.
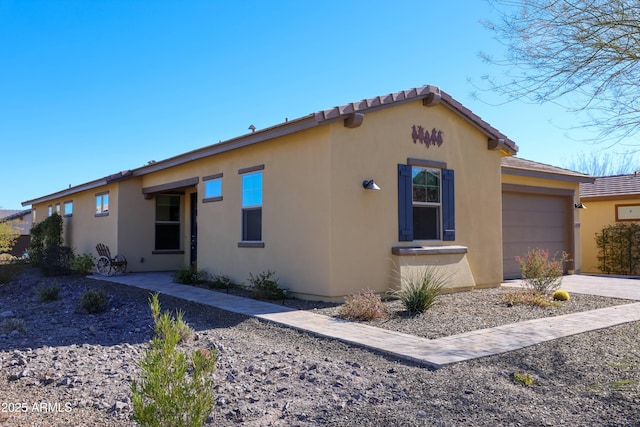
580, 173, 640, 273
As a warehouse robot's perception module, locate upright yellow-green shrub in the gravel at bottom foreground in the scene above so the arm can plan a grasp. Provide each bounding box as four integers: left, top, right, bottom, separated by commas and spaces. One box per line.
131, 293, 217, 427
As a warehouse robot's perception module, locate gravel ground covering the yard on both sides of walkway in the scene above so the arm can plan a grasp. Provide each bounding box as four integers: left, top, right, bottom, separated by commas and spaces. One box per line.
0, 272, 640, 426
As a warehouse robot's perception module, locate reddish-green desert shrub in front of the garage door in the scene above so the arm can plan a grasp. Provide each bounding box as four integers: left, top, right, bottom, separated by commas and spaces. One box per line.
516, 249, 569, 294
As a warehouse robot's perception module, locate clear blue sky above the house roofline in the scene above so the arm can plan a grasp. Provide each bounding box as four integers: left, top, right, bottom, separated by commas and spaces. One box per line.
0, 0, 620, 209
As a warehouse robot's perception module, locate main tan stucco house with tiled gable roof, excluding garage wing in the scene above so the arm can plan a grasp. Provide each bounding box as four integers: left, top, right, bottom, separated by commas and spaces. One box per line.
23, 86, 577, 299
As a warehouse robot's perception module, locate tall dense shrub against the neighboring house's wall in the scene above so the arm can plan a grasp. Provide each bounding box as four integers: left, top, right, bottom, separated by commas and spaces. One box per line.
596, 222, 640, 275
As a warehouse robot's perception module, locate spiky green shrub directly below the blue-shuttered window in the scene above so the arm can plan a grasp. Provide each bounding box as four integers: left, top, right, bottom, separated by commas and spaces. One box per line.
391, 267, 449, 313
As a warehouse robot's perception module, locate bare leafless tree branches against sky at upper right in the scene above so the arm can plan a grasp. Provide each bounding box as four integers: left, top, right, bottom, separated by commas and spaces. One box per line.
481, 0, 640, 141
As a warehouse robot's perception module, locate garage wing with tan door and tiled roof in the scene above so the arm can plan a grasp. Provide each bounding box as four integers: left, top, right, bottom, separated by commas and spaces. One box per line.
502, 157, 595, 279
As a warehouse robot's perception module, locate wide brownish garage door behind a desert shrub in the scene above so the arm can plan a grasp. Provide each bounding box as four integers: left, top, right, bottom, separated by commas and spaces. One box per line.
502, 192, 572, 279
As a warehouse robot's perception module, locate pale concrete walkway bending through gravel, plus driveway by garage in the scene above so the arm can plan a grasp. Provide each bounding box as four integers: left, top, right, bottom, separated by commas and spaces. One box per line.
90, 273, 640, 368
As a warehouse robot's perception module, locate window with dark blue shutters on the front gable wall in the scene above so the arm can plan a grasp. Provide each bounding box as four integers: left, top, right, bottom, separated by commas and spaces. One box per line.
398, 161, 455, 241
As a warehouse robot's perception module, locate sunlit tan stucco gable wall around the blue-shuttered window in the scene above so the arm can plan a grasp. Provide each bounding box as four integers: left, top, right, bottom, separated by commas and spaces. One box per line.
331, 101, 502, 295
